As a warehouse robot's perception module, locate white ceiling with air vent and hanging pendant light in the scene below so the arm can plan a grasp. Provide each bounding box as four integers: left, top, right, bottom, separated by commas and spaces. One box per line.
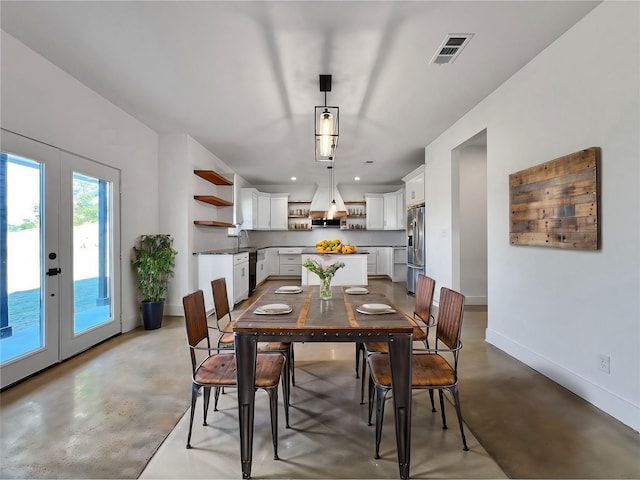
0, 0, 599, 185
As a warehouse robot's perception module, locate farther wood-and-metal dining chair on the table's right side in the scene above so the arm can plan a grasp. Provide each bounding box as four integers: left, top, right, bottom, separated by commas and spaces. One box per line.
356, 274, 436, 404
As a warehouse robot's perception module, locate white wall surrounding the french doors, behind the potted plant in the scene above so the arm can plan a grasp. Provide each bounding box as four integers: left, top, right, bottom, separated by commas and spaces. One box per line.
0, 32, 158, 331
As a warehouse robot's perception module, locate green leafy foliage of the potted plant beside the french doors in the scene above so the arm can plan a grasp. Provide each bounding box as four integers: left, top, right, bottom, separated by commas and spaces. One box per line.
131, 234, 178, 302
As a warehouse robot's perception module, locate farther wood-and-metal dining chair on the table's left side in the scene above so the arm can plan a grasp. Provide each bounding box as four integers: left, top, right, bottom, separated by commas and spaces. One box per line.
211, 277, 295, 428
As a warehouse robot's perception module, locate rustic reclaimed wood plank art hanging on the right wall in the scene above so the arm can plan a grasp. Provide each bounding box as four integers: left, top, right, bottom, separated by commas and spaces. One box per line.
509, 147, 600, 250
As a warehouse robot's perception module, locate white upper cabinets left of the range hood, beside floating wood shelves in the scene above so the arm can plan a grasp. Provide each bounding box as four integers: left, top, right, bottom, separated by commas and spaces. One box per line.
240, 188, 289, 230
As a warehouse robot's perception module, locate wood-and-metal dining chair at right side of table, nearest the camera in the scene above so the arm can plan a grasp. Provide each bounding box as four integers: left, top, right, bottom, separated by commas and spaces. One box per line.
367, 287, 469, 458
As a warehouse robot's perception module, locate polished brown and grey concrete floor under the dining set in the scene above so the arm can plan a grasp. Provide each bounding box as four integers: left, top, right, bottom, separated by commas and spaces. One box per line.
0, 280, 640, 478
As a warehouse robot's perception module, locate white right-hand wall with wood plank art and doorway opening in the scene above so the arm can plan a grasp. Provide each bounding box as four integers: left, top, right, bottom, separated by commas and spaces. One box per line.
425, 2, 640, 430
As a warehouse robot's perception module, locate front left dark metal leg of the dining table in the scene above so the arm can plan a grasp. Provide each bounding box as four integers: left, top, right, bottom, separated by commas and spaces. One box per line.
235, 333, 257, 478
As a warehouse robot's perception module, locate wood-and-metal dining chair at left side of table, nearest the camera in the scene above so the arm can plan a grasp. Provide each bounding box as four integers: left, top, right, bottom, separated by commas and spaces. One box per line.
182, 290, 289, 460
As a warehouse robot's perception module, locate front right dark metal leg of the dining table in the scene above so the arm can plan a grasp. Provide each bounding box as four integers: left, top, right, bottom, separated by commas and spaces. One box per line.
389, 334, 413, 479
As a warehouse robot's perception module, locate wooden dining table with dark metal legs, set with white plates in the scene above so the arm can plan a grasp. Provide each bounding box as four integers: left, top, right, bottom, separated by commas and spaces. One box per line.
233, 286, 418, 479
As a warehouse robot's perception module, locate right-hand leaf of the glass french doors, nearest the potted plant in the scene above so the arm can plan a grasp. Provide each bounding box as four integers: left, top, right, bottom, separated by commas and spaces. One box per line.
60, 152, 121, 359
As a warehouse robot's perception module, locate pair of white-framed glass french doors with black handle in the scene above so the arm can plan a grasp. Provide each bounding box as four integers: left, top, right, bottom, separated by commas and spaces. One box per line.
0, 131, 121, 387
